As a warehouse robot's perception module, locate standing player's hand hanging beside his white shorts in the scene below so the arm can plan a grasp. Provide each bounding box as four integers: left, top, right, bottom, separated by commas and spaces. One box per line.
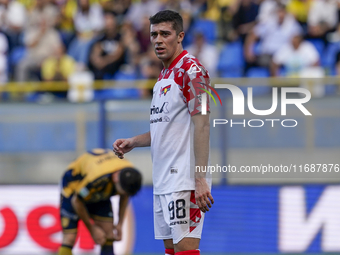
195, 178, 214, 213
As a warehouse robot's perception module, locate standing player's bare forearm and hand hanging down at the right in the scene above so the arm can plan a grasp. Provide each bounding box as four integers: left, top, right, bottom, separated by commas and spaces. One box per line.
191, 113, 214, 212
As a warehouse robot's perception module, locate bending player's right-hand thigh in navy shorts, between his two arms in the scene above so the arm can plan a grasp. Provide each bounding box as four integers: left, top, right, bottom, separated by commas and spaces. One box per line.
86, 199, 113, 240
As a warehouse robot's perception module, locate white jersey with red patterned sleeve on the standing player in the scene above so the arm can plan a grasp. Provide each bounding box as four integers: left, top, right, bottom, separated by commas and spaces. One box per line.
150, 51, 210, 195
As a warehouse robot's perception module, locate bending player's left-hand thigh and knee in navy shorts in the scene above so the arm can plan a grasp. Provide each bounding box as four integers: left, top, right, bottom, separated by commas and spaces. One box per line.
60, 196, 79, 246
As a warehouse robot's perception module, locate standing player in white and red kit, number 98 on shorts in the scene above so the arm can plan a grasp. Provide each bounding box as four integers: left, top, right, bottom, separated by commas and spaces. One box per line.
113, 10, 214, 255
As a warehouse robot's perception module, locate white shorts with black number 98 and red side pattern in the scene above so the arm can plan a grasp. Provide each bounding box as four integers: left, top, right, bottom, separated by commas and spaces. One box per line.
153, 190, 204, 244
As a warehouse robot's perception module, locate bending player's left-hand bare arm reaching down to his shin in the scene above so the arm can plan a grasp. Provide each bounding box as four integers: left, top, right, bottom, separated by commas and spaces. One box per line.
71, 194, 106, 245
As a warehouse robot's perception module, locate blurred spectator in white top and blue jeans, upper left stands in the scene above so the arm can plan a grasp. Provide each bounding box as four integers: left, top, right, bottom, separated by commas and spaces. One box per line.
68, 0, 105, 68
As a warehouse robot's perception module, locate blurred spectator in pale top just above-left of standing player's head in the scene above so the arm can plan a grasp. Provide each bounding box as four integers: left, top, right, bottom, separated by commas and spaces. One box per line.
125, 0, 161, 31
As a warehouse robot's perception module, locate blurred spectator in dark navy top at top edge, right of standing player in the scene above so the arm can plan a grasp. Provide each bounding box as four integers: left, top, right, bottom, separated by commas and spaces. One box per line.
232, 0, 259, 42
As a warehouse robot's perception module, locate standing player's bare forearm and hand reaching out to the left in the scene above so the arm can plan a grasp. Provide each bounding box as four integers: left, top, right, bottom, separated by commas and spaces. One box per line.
112, 131, 151, 159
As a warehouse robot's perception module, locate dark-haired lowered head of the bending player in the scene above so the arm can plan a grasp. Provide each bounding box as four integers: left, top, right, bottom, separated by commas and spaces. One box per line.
119, 167, 142, 196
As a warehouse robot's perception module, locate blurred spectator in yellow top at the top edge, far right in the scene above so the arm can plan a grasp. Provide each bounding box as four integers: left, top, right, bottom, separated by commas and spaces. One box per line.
287, 0, 313, 27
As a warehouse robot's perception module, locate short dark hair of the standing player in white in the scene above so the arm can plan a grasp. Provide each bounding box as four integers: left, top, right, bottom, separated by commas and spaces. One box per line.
149, 10, 183, 34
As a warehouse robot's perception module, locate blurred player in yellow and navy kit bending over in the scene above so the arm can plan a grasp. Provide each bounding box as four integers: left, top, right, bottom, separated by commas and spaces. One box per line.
58, 149, 142, 255
